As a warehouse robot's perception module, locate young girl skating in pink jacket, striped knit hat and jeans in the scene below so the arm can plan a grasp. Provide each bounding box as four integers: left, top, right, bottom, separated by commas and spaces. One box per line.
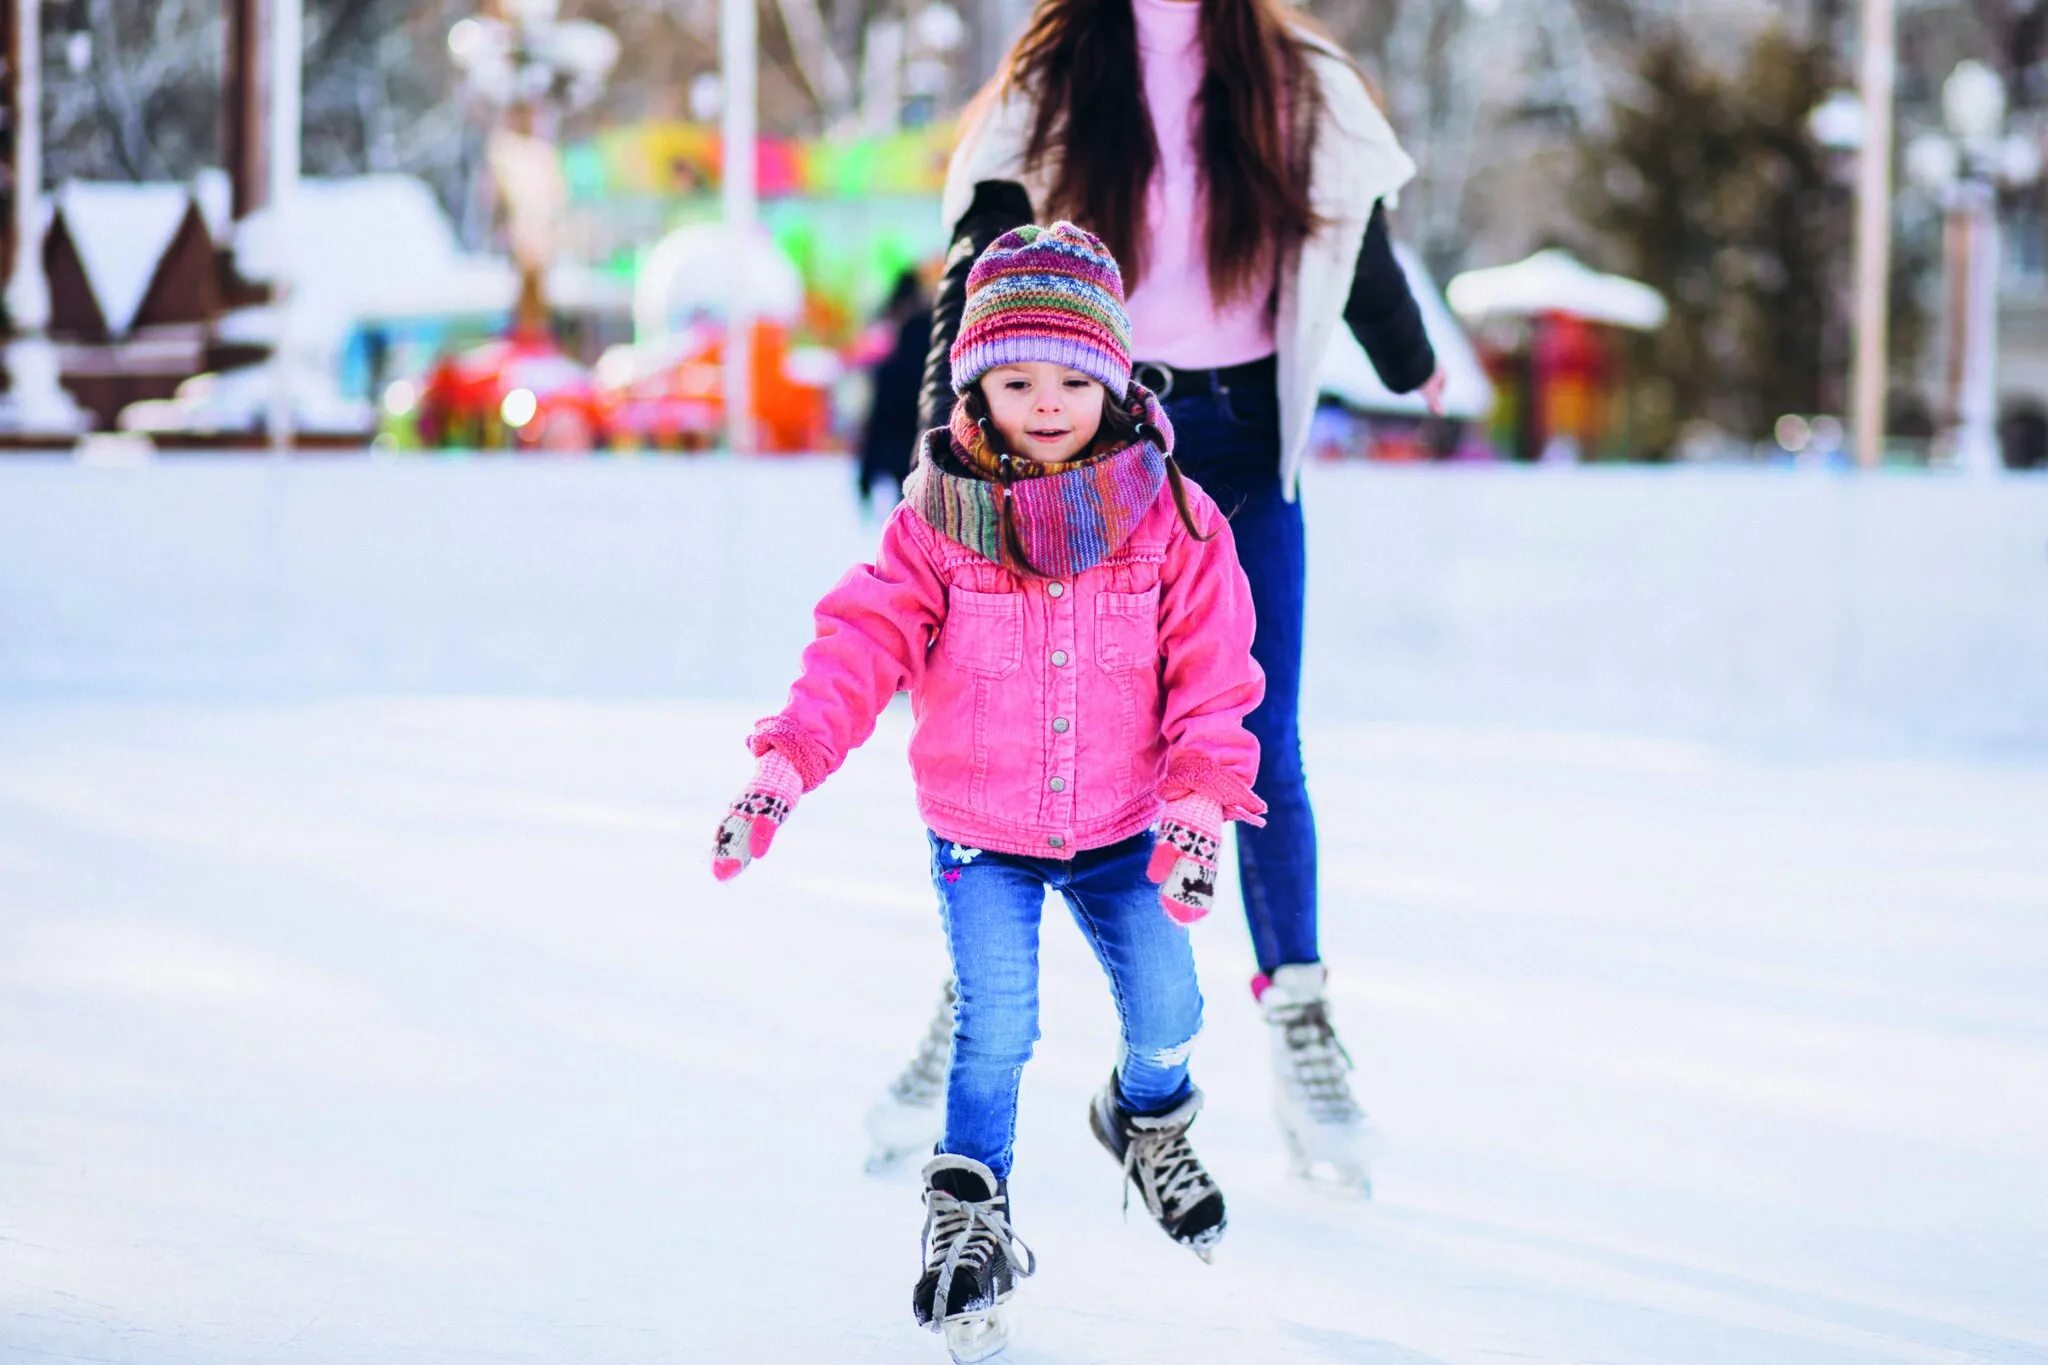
713, 223, 1266, 1359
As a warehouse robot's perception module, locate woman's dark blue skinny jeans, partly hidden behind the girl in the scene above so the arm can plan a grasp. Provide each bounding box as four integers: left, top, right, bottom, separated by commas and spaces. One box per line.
1165, 368, 1321, 974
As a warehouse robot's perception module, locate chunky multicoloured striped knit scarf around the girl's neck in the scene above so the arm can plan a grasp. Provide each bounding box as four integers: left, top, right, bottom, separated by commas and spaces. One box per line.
903, 383, 1174, 577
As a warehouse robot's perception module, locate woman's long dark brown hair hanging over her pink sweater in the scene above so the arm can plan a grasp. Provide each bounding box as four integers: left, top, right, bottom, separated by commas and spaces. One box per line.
991, 0, 1323, 301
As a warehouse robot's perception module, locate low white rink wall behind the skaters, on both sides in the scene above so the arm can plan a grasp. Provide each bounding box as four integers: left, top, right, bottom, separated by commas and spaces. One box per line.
0, 456, 2048, 757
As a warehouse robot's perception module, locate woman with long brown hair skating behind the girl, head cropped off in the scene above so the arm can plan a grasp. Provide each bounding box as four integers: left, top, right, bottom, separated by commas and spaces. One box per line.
868, 0, 1444, 1189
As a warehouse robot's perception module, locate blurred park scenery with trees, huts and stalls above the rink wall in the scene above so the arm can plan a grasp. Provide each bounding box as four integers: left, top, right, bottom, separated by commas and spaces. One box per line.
0, 0, 2048, 469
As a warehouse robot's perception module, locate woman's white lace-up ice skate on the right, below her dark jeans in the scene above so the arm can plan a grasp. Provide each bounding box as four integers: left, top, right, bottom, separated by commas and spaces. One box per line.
1253, 962, 1374, 1199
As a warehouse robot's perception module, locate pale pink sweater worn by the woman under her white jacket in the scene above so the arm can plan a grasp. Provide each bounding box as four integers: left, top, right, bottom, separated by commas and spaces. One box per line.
1126, 0, 1274, 368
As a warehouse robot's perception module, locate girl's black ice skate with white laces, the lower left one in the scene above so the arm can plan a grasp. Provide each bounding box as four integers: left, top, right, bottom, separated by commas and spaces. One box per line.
911, 1156, 1038, 1361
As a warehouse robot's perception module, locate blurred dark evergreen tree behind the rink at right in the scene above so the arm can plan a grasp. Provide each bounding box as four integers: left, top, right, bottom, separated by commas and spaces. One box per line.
1581, 29, 1917, 450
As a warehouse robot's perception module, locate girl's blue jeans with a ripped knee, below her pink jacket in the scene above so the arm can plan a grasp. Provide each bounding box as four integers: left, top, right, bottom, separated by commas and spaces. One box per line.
928, 831, 1202, 1179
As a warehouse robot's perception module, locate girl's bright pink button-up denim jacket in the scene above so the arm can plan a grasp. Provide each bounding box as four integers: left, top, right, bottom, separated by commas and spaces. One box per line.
748, 481, 1266, 857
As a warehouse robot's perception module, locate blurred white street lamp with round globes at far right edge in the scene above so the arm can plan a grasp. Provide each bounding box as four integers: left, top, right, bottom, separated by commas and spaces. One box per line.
1905, 61, 2042, 473
